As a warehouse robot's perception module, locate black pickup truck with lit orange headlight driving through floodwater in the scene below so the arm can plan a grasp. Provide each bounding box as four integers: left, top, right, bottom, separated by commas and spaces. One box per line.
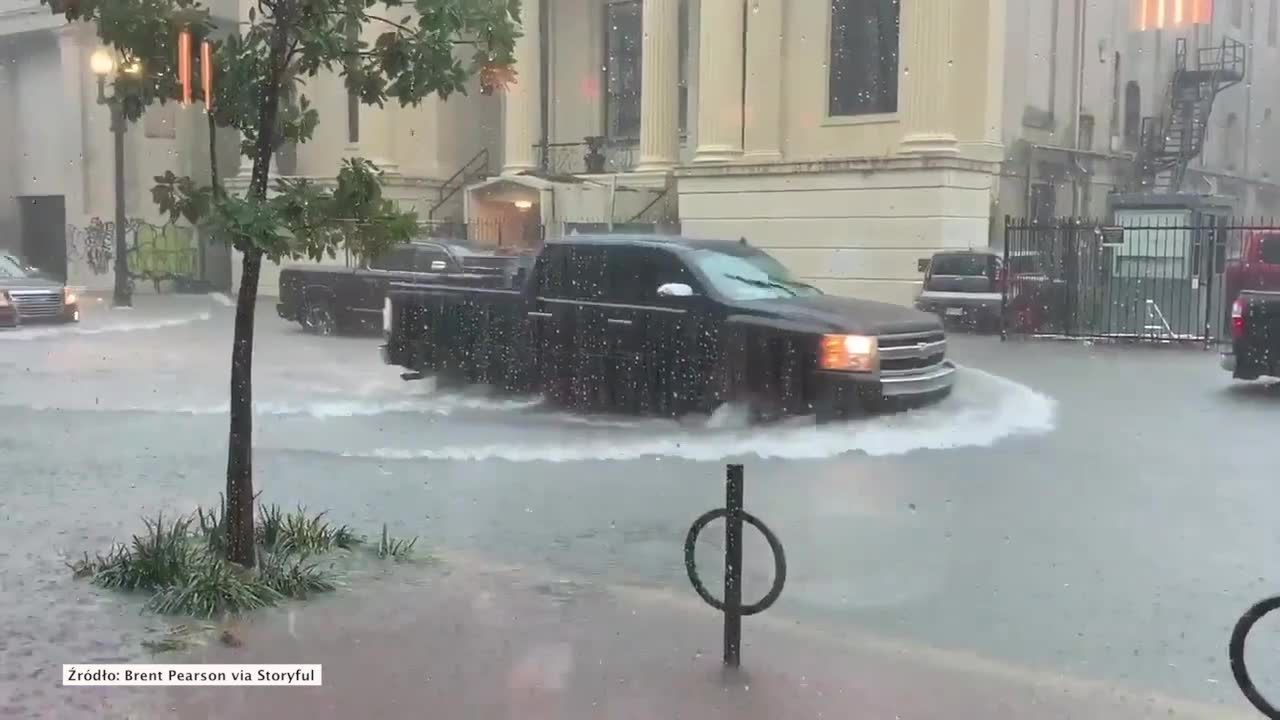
381, 236, 955, 420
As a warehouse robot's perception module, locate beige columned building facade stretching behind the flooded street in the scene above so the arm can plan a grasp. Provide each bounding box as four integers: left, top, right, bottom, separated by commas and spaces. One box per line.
0, 0, 1280, 302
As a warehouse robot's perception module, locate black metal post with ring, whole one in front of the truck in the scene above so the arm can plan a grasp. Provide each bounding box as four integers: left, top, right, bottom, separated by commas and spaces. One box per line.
685, 465, 787, 667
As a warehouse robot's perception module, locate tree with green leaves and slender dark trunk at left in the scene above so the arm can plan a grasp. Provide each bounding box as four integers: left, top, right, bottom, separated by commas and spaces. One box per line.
42, 0, 520, 568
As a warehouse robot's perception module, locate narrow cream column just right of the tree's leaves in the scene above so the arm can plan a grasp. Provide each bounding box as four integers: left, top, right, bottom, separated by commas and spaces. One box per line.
502, 0, 543, 176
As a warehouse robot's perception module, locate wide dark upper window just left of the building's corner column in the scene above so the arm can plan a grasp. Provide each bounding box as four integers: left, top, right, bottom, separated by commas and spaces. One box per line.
827, 0, 901, 117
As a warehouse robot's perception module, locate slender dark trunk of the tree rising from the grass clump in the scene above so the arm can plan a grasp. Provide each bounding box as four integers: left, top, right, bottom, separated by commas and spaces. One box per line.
227, 16, 292, 568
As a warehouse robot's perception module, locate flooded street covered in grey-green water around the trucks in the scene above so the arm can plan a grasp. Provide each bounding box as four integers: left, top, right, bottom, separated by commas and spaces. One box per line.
0, 297, 1280, 708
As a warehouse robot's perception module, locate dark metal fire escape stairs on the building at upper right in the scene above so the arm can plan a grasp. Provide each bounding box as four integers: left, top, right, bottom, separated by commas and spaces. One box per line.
1138, 37, 1245, 192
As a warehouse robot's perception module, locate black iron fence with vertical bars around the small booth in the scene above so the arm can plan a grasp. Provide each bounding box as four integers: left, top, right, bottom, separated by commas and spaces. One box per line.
1001, 214, 1280, 345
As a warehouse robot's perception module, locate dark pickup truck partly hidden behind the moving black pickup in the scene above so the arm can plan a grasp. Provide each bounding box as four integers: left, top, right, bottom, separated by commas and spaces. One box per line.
275, 241, 532, 334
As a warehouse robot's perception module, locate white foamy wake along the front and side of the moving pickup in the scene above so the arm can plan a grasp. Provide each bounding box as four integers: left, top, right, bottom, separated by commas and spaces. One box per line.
343, 368, 1056, 462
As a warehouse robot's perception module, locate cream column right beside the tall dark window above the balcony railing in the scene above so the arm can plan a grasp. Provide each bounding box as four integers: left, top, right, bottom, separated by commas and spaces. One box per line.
635, 0, 680, 173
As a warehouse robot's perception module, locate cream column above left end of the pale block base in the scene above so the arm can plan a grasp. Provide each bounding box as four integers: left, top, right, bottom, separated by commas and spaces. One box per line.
694, 0, 746, 163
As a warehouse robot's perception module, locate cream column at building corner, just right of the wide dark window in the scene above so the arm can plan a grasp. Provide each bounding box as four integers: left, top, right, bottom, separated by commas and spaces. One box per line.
900, 0, 956, 154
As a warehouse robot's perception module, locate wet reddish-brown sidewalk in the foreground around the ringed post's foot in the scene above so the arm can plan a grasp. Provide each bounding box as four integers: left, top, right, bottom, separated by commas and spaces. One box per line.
115, 564, 1249, 720
